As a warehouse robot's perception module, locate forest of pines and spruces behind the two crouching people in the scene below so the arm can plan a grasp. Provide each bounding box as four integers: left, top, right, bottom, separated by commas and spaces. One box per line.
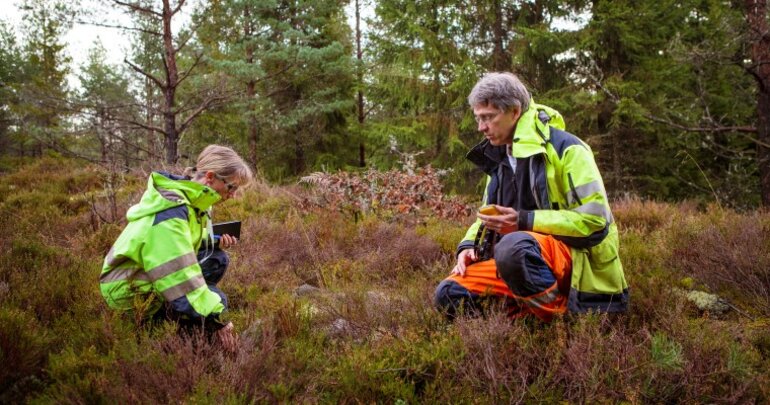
0, 0, 770, 205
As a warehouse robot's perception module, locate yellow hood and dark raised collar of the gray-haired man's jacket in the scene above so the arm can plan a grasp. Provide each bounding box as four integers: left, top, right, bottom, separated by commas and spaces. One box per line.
466, 100, 565, 174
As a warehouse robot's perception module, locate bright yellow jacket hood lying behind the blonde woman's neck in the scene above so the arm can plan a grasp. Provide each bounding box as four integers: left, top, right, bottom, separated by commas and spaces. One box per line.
126, 172, 222, 221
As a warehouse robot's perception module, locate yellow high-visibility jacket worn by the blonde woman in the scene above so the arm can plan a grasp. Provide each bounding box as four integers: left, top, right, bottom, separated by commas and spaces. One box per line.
99, 172, 224, 323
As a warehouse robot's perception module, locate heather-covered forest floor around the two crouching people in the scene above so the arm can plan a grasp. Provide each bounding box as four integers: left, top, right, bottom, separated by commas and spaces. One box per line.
0, 157, 770, 403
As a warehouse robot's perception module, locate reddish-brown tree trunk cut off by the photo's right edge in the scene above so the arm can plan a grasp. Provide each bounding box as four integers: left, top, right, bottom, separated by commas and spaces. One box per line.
746, 0, 770, 208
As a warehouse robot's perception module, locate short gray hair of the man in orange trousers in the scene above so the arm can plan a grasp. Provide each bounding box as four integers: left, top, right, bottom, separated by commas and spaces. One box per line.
468, 72, 531, 112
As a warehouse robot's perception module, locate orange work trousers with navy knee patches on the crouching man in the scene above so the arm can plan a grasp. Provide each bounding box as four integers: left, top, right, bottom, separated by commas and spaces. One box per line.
436, 231, 572, 321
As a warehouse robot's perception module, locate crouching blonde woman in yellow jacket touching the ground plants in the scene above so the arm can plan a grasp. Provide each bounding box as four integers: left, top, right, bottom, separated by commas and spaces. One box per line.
100, 145, 253, 350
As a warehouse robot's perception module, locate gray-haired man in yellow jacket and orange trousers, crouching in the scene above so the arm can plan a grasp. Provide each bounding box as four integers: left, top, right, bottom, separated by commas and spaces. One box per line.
435, 72, 629, 321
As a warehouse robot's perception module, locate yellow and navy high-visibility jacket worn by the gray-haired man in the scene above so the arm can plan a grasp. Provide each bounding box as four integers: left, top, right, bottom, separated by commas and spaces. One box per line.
458, 102, 629, 312
